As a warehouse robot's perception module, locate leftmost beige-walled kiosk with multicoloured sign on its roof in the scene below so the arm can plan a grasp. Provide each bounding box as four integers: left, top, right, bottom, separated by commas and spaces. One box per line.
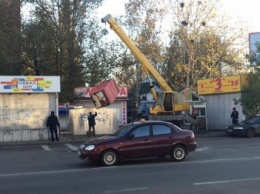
0, 76, 60, 142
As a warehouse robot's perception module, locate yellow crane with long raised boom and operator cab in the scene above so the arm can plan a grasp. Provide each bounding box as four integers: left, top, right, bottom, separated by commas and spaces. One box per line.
101, 14, 196, 123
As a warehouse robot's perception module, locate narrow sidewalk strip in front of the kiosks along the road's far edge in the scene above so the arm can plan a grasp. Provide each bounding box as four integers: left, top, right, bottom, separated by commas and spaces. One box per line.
0, 130, 226, 149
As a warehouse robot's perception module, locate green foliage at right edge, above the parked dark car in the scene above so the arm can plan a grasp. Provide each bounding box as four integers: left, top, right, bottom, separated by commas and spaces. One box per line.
234, 68, 260, 116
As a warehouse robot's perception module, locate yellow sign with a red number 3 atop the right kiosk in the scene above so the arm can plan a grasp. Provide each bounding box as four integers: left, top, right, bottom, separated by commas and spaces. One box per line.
198, 75, 248, 95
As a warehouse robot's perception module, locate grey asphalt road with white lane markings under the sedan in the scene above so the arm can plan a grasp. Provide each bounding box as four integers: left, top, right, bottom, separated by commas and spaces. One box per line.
0, 136, 260, 194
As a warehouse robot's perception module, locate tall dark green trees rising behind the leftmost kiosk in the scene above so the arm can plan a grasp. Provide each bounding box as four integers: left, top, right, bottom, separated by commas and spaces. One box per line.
22, 0, 108, 102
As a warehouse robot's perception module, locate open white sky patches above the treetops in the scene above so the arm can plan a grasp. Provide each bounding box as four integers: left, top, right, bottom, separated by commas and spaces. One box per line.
99, 0, 260, 33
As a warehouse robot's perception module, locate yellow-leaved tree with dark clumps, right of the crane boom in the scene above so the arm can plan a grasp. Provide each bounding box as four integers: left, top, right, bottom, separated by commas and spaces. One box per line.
167, 0, 246, 90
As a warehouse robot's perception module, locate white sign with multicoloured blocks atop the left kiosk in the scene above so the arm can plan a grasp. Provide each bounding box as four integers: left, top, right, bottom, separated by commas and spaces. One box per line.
0, 76, 60, 93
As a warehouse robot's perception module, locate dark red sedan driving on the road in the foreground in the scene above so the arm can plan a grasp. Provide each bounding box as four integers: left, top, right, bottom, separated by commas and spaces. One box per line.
78, 121, 197, 166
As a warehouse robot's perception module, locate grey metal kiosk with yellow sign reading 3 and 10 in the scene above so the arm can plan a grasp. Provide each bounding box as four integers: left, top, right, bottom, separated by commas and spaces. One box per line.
198, 75, 247, 130
